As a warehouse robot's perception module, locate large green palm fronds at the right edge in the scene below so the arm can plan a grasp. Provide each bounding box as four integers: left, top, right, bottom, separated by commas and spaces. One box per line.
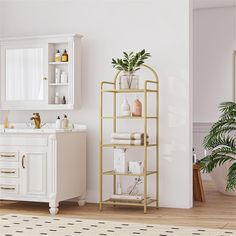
200, 102, 236, 191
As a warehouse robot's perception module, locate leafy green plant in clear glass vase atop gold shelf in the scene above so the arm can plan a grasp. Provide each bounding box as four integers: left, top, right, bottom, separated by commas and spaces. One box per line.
112, 49, 151, 89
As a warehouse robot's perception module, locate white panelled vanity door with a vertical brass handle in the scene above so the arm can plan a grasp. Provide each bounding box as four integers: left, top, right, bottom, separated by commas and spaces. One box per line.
21, 150, 47, 197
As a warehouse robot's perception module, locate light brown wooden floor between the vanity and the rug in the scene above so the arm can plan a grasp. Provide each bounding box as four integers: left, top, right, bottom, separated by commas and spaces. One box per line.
0, 182, 236, 230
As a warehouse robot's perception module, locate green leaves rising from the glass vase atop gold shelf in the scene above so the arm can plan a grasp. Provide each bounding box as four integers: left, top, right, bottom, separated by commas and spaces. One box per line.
111, 49, 151, 73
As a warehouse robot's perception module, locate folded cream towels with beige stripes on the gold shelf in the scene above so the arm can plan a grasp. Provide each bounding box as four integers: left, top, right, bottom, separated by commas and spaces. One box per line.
111, 133, 148, 145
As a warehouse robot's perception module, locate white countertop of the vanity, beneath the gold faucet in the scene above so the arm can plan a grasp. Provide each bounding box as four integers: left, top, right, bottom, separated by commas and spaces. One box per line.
0, 123, 87, 134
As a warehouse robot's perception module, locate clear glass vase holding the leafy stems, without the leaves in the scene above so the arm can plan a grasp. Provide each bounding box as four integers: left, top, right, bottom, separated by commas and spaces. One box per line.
119, 72, 139, 89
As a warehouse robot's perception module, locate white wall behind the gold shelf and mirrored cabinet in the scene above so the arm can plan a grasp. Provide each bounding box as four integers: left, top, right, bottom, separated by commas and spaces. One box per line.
0, 0, 192, 208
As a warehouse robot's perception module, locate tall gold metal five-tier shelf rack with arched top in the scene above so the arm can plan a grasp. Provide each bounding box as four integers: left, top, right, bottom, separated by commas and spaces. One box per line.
99, 65, 159, 213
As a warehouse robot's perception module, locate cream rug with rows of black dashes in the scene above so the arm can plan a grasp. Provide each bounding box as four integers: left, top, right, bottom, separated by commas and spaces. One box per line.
0, 214, 236, 236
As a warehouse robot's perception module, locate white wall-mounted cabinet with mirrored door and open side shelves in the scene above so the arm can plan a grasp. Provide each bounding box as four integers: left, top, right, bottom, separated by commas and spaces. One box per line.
0, 34, 82, 110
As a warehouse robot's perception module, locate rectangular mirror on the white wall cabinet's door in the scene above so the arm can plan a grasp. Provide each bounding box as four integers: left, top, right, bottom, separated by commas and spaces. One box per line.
6, 48, 45, 101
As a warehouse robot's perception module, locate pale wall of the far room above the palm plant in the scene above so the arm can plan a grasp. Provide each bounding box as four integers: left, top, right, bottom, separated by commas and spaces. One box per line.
193, 7, 236, 122
